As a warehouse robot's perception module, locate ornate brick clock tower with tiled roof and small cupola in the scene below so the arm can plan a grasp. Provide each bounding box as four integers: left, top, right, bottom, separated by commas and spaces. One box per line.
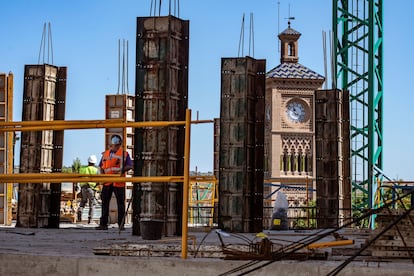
264, 22, 325, 226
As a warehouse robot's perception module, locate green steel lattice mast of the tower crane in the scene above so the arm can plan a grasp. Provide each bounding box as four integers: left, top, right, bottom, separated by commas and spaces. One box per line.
332, 0, 384, 226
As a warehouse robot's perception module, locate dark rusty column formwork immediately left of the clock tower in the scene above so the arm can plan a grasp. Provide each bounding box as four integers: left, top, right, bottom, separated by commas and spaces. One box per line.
218, 57, 266, 233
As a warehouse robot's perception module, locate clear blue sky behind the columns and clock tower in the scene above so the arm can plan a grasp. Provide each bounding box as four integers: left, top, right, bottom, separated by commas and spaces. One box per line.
0, 0, 414, 180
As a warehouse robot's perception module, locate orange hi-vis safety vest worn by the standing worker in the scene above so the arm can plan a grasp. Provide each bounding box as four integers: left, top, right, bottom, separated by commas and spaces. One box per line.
101, 148, 128, 187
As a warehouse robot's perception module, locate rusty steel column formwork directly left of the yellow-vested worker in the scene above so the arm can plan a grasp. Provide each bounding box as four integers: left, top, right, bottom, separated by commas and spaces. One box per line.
16, 64, 67, 228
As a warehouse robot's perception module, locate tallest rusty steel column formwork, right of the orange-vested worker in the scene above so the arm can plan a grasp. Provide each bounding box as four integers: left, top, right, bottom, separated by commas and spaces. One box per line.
133, 16, 189, 239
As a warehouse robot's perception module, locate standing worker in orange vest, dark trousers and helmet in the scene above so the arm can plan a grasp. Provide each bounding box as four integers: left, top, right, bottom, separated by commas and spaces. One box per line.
96, 134, 133, 230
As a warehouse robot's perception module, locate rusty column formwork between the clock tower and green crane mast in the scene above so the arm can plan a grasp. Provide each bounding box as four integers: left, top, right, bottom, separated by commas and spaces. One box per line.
315, 89, 351, 228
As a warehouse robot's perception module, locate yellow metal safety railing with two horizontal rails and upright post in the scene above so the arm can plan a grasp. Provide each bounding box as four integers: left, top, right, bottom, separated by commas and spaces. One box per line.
0, 109, 214, 259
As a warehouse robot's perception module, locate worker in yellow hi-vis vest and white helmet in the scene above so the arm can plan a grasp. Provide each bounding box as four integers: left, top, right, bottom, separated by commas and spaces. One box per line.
77, 155, 99, 224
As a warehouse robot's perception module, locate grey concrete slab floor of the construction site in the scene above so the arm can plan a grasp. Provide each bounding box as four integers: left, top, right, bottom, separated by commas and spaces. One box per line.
0, 223, 414, 276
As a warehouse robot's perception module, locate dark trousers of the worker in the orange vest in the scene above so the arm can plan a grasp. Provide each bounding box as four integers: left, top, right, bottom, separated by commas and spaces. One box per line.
100, 184, 125, 226
